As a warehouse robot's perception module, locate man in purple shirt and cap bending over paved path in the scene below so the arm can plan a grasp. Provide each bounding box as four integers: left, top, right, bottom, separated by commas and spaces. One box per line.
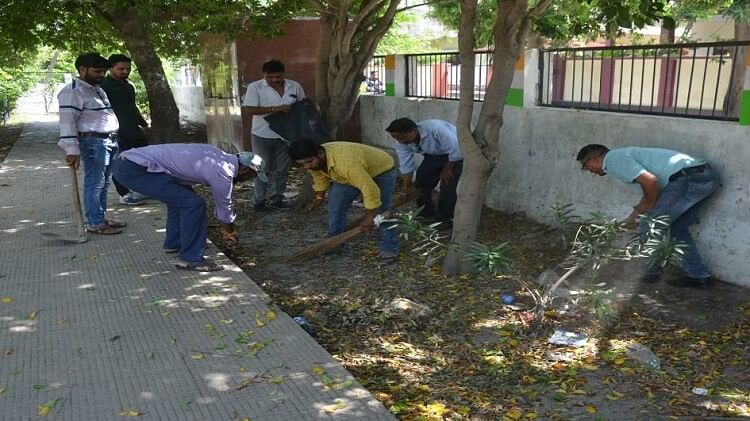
113, 143, 268, 272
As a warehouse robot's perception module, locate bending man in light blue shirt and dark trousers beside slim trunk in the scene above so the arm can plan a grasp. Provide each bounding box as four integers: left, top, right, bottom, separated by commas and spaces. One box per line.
385, 118, 464, 229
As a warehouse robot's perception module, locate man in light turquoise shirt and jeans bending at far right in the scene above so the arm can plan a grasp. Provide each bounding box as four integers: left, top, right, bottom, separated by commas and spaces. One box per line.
576, 144, 719, 288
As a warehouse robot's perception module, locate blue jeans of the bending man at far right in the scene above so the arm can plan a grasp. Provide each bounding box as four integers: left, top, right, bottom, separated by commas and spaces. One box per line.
640, 168, 719, 279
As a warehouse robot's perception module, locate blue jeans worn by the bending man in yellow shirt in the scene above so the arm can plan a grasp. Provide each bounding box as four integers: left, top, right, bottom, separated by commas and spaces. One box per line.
328, 170, 398, 253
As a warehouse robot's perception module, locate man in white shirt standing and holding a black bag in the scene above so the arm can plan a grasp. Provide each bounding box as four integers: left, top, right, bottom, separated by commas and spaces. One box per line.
242, 60, 305, 212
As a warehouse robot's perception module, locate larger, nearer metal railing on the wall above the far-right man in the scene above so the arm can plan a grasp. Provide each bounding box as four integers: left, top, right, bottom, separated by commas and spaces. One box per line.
537, 41, 750, 120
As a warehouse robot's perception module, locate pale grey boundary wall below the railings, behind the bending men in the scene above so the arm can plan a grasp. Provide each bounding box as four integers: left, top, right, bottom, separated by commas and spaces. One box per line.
360, 96, 750, 286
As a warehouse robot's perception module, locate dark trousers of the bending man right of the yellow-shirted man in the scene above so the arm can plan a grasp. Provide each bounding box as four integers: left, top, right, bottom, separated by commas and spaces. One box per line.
414, 155, 464, 221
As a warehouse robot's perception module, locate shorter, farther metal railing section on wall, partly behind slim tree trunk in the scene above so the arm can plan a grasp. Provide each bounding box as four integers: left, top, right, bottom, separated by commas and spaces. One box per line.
405, 51, 492, 101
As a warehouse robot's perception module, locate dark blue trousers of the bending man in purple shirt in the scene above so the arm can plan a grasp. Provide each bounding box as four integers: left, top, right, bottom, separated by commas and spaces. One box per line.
114, 158, 208, 263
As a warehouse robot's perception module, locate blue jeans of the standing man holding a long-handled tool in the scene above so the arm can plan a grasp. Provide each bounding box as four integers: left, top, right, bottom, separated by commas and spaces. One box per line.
79, 137, 119, 228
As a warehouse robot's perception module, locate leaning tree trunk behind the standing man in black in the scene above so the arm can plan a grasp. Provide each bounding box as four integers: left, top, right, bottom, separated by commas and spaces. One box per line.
105, 9, 180, 143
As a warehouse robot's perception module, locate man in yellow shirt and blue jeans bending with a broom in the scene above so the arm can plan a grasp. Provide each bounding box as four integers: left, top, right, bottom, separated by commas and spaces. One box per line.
289, 139, 398, 263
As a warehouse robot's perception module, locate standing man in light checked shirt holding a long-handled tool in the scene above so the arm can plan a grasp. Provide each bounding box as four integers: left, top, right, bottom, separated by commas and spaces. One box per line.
57, 53, 127, 234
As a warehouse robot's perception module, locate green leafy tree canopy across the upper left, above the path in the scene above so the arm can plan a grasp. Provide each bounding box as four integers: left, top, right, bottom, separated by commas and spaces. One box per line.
0, 0, 301, 64
